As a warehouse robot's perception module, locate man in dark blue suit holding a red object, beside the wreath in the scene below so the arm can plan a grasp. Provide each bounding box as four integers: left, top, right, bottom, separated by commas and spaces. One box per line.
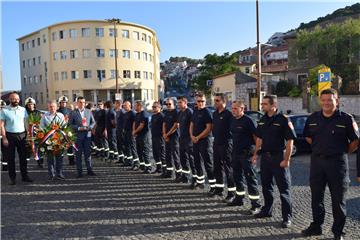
69, 97, 95, 178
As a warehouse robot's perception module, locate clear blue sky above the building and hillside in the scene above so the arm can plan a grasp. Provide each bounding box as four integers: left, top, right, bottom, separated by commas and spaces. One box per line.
1, 1, 356, 90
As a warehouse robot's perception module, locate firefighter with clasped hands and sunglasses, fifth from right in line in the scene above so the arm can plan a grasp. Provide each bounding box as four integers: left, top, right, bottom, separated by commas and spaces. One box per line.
189, 93, 216, 191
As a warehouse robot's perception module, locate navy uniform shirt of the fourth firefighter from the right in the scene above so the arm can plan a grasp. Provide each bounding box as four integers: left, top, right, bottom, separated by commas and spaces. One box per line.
212, 109, 233, 144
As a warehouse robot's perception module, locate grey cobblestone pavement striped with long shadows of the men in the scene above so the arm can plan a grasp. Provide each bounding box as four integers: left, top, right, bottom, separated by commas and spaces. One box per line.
1, 155, 360, 240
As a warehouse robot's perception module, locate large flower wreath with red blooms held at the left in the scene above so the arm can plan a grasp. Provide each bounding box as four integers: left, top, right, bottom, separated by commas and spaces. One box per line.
32, 121, 77, 159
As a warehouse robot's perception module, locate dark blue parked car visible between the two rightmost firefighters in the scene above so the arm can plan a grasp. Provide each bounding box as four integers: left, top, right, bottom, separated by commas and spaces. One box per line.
288, 114, 311, 156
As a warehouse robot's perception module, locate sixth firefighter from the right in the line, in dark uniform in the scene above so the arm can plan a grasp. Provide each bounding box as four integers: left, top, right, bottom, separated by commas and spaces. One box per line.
177, 96, 196, 188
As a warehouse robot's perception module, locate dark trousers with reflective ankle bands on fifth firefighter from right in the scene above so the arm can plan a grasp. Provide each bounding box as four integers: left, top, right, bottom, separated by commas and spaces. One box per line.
194, 137, 216, 185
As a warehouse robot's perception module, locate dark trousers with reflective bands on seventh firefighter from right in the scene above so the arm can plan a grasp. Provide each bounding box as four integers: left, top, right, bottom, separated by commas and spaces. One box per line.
165, 134, 182, 175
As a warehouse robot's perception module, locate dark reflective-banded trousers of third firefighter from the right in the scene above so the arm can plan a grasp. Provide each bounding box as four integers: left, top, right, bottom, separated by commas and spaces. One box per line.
232, 150, 260, 207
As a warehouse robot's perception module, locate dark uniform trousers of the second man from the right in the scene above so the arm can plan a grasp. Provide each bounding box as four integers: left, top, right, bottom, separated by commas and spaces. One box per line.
260, 151, 292, 220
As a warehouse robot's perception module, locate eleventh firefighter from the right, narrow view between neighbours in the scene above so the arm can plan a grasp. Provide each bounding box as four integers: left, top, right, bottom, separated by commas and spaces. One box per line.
115, 100, 125, 163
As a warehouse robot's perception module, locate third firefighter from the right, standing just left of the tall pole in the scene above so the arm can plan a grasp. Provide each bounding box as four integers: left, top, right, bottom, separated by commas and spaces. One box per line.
228, 100, 261, 215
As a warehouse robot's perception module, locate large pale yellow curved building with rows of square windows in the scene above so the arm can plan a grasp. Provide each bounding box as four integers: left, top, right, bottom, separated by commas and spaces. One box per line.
17, 20, 160, 108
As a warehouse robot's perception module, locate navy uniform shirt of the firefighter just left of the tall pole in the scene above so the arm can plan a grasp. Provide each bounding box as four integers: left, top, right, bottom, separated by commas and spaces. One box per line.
230, 114, 256, 153
